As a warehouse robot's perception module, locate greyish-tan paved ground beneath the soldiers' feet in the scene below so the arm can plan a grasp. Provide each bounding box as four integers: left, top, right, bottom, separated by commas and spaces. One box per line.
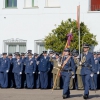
0, 89, 100, 100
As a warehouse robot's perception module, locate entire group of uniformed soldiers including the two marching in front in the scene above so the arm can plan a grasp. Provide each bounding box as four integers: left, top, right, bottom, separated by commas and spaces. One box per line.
0, 44, 100, 99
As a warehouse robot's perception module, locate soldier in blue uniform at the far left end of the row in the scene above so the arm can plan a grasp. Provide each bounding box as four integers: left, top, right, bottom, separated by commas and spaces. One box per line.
0, 53, 10, 88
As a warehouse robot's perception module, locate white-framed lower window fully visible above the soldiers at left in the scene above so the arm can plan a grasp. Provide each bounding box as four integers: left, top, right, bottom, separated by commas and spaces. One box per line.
3, 39, 26, 53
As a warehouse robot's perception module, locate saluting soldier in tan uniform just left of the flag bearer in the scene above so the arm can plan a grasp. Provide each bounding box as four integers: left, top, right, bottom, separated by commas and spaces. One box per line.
50, 53, 61, 90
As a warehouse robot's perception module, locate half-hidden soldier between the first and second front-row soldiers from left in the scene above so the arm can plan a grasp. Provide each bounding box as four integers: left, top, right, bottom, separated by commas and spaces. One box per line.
8, 53, 14, 88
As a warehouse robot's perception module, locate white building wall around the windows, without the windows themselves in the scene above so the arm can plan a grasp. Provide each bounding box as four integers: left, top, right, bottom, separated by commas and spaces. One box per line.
0, 0, 100, 52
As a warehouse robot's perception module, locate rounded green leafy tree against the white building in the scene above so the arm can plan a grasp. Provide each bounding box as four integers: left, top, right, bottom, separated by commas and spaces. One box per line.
44, 19, 98, 53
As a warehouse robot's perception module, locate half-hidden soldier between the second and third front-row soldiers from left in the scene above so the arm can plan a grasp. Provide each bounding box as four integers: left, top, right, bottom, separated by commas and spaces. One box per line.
21, 53, 26, 88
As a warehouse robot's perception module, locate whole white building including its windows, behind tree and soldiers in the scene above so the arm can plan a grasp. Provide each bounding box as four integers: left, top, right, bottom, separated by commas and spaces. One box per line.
0, 0, 100, 53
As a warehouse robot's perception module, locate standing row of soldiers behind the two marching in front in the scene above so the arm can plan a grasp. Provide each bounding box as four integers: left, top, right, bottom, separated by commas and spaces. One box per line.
0, 47, 100, 90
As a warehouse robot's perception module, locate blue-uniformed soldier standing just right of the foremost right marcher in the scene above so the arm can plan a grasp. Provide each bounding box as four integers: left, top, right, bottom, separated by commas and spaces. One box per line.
90, 52, 100, 90
